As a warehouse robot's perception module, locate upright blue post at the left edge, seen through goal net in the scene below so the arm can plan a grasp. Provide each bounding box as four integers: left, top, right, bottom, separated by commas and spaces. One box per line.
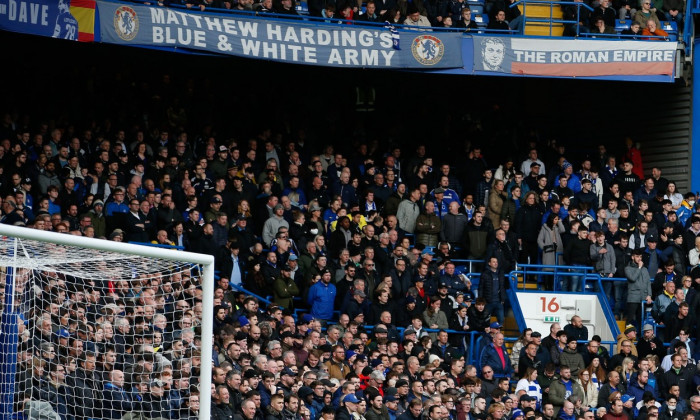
0, 239, 18, 420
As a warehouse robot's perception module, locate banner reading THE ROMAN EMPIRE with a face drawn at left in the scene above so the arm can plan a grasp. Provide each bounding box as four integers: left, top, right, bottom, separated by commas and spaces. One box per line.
473, 36, 676, 77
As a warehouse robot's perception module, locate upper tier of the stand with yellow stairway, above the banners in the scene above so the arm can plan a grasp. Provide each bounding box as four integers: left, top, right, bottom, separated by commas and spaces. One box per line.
134, 0, 685, 35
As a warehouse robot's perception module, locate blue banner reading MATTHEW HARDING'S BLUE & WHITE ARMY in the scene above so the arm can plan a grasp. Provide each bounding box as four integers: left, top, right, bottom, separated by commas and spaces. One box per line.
97, 1, 463, 69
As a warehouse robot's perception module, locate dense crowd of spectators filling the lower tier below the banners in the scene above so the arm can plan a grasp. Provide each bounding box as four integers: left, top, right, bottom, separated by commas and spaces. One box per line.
0, 84, 700, 420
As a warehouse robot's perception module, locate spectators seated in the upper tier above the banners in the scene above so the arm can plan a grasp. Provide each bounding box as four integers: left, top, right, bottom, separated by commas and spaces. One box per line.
152, 0, 686, 40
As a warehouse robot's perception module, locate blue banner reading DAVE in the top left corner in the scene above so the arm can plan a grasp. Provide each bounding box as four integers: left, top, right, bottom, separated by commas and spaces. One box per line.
0, 0, 79, 41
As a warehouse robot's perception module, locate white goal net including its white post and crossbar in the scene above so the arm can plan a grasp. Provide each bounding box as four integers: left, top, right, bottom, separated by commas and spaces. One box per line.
0, 225, 214, 420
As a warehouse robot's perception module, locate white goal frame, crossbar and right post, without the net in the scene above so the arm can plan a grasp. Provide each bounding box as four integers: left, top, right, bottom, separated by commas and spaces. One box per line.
0, 224, 214, 420
